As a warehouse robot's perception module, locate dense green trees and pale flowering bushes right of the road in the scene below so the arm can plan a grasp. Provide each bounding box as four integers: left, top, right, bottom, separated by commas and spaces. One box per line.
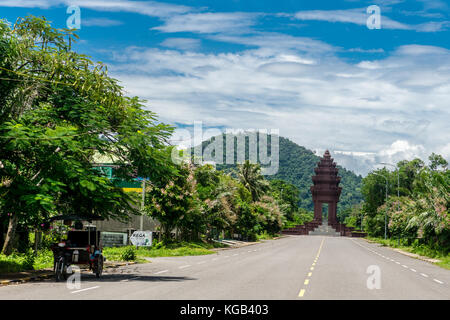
362, 154, 450, 254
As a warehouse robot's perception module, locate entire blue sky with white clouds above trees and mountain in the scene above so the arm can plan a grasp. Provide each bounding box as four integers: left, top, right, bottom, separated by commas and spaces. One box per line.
0, 0, 450, 174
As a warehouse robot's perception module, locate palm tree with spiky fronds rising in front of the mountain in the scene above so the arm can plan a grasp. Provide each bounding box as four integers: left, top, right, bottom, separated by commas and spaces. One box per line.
238, 160, 270, 201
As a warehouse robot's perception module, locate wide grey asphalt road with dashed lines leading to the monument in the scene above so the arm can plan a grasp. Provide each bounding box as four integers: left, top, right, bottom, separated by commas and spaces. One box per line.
0, 236, 450, 300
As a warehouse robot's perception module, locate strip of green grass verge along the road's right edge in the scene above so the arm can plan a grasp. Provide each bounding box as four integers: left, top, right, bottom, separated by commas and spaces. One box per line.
367, 237, 450, 270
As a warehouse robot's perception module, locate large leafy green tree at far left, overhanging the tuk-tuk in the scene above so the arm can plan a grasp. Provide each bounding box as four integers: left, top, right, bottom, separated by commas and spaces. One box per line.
0, 16, 172, 254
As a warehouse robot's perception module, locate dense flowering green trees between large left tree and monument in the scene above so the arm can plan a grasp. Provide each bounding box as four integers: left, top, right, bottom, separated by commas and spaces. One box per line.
146, 162, 286, 240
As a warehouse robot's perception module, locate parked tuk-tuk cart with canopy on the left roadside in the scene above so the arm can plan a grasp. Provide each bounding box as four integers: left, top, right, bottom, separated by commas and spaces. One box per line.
50, 216, 106, 281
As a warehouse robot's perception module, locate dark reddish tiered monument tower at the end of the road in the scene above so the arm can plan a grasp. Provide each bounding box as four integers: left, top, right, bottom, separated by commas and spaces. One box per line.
311, 150, 342, 225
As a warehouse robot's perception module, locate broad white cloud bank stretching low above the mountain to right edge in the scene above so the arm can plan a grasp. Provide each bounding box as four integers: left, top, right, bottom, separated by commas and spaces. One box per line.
104, 37, 450, 173
